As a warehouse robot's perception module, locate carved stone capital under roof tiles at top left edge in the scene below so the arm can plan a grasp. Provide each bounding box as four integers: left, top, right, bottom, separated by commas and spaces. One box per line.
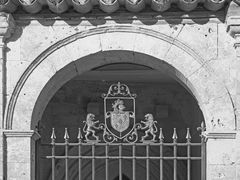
0, 12, 15, 40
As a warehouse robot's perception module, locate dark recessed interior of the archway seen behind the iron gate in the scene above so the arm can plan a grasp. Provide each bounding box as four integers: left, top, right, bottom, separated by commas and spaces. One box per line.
37, 59, 203, 180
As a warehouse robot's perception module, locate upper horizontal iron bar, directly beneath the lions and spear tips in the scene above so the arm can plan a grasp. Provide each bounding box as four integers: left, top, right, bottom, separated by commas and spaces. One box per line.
41, 142, 202, 146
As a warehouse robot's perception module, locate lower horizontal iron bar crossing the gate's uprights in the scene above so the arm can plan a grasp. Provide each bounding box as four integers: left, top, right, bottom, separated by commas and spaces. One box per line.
45, 156, 202, 160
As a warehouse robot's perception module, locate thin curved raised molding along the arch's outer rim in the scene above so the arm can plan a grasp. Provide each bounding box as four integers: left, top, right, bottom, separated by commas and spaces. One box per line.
4, 25, 210, 129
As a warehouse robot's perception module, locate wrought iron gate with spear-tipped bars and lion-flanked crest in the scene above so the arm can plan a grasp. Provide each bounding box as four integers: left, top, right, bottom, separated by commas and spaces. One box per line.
46, 83, 206, 180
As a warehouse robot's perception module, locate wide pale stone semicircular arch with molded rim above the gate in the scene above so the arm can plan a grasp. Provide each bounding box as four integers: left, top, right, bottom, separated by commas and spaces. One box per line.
5, 26, 235, 130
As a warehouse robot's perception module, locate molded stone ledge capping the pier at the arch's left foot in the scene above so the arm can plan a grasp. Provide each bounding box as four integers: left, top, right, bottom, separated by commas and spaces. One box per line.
3, 130, 41, 141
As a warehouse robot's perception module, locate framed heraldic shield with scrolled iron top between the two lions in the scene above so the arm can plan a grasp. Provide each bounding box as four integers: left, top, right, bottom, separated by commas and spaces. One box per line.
103, 82, 136, 139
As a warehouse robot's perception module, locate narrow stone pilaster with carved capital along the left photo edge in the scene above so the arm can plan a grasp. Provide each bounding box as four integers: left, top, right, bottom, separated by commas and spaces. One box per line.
0, 12, 14, 180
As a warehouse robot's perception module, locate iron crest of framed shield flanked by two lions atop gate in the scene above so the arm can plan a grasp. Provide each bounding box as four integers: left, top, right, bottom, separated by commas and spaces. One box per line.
83, 82, 157, 143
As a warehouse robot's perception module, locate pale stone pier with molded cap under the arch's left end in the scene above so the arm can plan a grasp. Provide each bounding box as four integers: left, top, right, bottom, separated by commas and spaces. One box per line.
3, 130, 40, 180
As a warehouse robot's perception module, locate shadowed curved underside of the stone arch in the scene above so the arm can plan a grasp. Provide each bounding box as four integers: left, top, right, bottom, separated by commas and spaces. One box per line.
31, 51, 199, 129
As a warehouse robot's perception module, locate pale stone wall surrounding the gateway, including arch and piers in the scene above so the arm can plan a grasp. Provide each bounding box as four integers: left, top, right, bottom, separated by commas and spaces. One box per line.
0, 4, 240, 180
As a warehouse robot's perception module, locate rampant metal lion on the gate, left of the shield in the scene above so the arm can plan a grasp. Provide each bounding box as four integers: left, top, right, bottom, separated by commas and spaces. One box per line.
83, 113, 99, 141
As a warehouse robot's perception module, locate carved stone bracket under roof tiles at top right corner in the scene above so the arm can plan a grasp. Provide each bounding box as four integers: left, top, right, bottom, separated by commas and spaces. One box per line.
226, 1, 240, 57
